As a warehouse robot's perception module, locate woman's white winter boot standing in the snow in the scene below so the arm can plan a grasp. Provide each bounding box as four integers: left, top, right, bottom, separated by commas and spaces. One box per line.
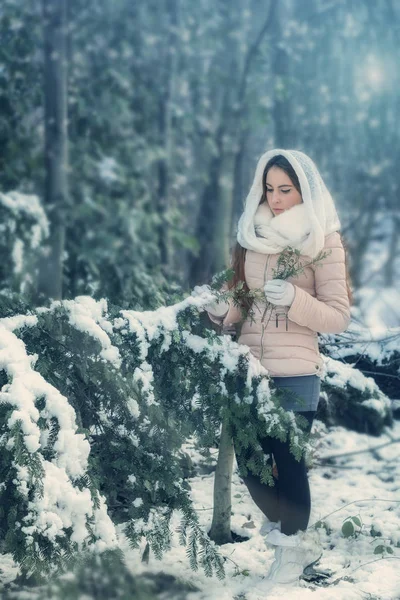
265, 529, 322, 585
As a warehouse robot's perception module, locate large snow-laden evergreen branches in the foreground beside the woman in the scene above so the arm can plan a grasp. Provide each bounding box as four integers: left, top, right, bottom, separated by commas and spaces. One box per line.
0, 295, 390, 577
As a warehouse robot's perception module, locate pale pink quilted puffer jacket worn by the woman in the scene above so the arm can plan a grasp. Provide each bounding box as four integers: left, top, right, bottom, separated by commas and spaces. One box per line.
208, 231, 350, 377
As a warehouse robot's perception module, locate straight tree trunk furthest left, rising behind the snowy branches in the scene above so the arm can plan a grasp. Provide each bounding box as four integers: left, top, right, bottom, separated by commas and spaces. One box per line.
38, 0, 68, 300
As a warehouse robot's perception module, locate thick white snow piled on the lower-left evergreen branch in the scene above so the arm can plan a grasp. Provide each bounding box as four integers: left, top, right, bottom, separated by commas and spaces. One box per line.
0, 323, 116, 572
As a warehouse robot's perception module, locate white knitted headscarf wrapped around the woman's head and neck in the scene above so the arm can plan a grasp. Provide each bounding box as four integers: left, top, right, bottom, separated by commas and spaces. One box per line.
237, 148, 341, 258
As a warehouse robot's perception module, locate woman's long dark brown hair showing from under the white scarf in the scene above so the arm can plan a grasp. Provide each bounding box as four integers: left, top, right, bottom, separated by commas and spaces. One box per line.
228, 154, 353, 311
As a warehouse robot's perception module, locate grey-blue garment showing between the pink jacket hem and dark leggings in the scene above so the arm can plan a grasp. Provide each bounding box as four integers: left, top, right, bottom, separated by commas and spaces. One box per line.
271, 375, 321, 412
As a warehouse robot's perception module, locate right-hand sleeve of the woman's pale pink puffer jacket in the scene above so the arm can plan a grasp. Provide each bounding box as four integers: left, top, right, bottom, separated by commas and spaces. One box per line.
288, 231, 351, 333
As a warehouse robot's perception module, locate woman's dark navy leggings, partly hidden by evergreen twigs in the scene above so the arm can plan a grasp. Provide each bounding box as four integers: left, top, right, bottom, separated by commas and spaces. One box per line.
233, 410, 316, 535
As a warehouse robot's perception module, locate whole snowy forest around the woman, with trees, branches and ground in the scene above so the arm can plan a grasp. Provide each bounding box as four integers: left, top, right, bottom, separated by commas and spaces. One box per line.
0, 0, 400, 600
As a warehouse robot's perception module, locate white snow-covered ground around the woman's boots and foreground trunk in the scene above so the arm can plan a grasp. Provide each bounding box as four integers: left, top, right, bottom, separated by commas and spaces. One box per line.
0, 412, 400, 600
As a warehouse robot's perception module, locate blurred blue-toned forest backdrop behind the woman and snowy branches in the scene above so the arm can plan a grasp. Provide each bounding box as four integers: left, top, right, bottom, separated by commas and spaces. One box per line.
0, 0, 400, 331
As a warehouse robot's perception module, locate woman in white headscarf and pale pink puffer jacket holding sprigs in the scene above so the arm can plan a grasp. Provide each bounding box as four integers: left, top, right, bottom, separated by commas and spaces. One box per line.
206, 149, 352, 583
